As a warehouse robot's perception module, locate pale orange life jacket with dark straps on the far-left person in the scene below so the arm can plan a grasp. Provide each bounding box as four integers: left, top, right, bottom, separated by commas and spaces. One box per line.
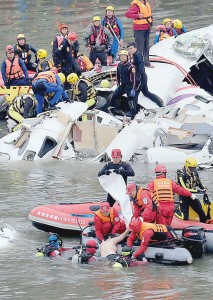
5, 57, 24, 80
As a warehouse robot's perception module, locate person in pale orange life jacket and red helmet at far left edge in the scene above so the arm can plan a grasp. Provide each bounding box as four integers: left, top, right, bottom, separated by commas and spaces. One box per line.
1, 45, 29, 88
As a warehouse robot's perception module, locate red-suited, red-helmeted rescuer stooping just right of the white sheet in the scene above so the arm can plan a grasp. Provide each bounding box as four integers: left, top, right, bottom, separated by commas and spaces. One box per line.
127, 183, 160, 223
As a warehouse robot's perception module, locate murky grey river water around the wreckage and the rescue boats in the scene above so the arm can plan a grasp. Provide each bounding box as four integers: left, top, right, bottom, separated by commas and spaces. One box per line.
0, 0, 213, 300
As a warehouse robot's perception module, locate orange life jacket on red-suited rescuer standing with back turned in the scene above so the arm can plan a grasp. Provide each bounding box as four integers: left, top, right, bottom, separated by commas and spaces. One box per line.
153, 178, 174, 202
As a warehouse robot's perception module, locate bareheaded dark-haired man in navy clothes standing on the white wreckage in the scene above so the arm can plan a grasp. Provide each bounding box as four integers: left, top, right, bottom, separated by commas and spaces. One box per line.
127, 42, 164, 107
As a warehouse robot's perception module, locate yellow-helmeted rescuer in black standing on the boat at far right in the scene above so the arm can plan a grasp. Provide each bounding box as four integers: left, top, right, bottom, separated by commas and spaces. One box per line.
177, 157, 209, 223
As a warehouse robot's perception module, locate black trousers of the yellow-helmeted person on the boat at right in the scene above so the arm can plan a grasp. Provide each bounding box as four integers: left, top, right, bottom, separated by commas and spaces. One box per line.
180, 196, 207, 223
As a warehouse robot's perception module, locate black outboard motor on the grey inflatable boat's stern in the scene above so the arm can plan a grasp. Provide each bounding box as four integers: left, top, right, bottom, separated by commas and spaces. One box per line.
182, 226, 206, 258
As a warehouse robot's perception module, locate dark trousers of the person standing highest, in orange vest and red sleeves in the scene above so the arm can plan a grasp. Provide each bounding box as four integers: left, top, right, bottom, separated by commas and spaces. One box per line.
134, 29, 150, 65
